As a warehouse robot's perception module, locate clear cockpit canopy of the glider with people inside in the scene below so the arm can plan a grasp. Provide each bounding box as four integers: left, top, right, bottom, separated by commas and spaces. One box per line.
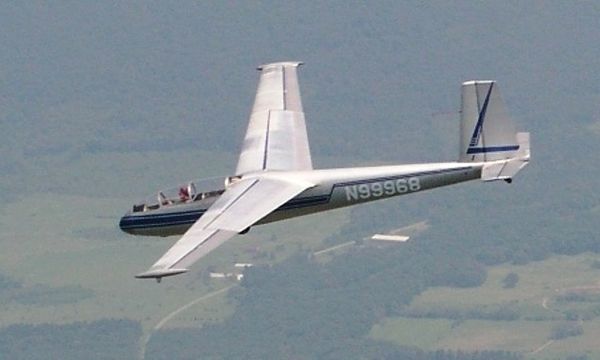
133, 177, 232, 213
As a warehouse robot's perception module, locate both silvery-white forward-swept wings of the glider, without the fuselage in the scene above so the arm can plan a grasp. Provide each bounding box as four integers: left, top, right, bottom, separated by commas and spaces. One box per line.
137, 62, 313, 279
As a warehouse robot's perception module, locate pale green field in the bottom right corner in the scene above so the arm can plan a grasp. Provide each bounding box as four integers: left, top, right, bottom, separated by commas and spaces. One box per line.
370, 254, 600, 359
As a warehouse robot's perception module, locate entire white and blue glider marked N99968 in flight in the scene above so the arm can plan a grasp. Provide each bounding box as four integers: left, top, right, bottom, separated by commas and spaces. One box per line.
119, 62, 530, 281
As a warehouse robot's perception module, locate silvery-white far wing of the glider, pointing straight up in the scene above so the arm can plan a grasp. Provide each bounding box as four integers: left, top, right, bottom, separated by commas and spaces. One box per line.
236, 62, 312, 175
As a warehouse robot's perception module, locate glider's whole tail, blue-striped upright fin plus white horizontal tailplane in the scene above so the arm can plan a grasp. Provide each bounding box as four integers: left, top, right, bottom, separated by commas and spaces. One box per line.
459, 81, 530, 181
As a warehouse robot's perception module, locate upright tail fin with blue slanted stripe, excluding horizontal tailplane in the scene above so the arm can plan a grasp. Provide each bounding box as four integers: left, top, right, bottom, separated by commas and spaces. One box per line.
459, 80, 519, 162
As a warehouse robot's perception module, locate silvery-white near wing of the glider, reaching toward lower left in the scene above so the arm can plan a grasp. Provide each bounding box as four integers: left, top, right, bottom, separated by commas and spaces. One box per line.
136, 178, 312, 279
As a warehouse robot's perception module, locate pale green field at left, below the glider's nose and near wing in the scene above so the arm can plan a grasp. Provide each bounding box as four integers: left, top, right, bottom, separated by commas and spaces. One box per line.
0, 181, 348, 329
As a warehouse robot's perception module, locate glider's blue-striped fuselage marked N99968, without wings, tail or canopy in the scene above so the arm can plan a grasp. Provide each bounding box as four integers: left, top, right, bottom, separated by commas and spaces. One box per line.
119, 162, 482, 236
